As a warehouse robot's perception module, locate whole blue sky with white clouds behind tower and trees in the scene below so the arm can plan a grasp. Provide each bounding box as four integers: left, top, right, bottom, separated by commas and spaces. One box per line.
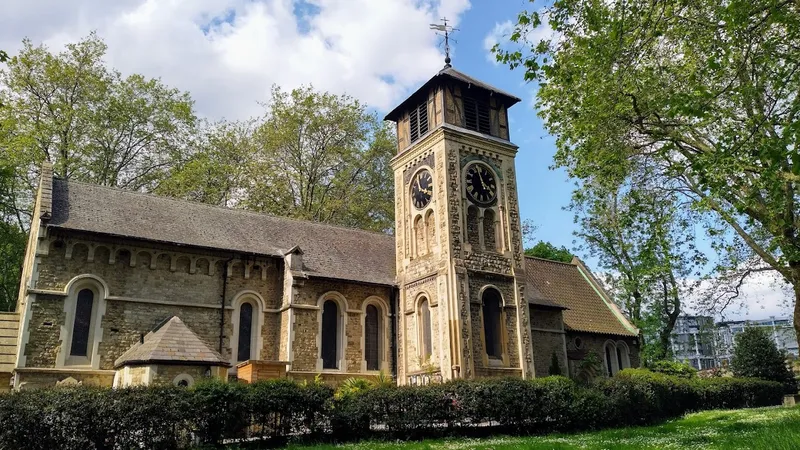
0, 0, 789, 319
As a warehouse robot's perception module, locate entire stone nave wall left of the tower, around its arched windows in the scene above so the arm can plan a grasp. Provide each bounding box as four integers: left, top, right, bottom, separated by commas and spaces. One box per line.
24, 231, 395, 384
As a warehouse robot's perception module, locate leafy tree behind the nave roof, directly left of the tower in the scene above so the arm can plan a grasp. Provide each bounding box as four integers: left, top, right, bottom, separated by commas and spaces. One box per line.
159, 87, 396, 231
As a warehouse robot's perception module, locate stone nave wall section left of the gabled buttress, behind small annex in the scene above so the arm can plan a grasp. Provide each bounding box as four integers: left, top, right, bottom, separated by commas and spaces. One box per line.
24, 231, 283, 369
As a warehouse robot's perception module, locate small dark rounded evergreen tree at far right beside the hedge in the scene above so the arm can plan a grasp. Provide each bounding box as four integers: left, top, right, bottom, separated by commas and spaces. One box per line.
731, 327, 797, 392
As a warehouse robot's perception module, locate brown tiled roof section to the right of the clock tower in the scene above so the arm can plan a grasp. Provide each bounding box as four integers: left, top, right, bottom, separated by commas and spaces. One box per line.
525, 256, 638, 336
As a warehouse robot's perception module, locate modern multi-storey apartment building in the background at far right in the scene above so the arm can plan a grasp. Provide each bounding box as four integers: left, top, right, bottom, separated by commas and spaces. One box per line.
671, 315, 800, 370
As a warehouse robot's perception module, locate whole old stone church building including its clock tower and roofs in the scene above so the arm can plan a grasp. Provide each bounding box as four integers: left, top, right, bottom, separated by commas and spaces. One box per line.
0, 64, 639, 388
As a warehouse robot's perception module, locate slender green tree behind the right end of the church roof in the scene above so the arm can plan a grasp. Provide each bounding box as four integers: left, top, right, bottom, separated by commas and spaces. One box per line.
570, 173, 706, 361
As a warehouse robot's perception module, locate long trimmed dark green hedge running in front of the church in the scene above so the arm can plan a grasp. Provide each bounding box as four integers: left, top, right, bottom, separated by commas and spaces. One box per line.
0, 369, 783, 449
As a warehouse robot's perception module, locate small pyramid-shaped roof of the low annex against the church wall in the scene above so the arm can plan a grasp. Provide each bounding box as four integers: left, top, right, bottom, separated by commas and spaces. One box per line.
114, 316, 230, 368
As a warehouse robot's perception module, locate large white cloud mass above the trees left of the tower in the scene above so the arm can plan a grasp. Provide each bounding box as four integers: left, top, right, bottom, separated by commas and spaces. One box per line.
0, 0, 470, 118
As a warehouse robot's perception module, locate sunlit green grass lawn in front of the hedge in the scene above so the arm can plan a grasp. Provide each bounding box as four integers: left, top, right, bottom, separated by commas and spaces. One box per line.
289, 407, 800, 450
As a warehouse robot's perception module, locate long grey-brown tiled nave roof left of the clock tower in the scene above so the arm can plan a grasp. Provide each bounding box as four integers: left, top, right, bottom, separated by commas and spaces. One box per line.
48, 179, 395, 286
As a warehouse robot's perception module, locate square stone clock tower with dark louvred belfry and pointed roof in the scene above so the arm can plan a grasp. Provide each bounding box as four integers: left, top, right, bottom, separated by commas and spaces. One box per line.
386, 63, 534, 384
